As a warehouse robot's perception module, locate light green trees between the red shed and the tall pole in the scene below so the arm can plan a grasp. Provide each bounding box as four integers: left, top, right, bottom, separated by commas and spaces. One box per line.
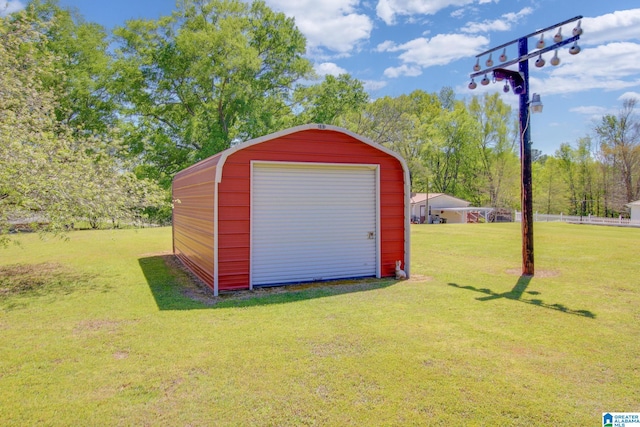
343, 87, 519, 207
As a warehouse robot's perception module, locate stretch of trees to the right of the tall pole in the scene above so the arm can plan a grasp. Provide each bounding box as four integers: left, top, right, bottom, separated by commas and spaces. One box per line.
534, 98, 640, 216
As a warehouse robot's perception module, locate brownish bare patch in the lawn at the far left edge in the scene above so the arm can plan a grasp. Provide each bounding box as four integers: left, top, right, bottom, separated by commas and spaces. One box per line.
0, 263, 92, 300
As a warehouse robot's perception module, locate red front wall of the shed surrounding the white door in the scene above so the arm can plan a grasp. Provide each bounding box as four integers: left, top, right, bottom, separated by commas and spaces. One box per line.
218, 129, 406, 290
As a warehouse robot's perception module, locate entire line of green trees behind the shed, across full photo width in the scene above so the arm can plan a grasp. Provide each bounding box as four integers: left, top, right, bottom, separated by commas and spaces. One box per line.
0, 0, 640, 241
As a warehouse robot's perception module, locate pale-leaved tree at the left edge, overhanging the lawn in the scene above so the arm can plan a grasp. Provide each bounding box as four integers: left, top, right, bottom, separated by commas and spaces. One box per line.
0, 12, 165, 242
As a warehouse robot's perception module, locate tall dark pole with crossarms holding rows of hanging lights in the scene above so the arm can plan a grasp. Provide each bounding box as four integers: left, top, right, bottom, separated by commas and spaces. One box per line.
469, 16, 583, 276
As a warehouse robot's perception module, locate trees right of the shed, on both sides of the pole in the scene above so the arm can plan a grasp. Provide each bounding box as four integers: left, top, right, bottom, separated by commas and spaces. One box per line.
342, 88, 640, 217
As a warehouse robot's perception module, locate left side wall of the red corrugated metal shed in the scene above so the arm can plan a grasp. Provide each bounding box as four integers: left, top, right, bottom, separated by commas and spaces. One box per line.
172, 157, 219, 289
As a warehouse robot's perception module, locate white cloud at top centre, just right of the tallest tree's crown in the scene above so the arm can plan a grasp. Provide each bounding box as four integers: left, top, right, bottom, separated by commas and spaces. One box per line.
267, 0, 373, 56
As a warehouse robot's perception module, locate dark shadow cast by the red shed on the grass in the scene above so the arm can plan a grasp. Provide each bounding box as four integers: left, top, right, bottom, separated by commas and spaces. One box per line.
138, 255, 397, 310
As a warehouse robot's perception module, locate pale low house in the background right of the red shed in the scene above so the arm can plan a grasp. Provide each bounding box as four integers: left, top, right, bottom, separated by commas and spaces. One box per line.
411, 193, 493, 224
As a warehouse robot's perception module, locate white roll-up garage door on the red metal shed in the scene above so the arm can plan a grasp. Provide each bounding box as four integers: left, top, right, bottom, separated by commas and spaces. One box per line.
251, 163, 379, 286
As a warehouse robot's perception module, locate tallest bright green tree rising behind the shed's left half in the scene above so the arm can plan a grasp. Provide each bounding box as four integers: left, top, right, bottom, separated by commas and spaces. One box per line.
113, 0, 311, 186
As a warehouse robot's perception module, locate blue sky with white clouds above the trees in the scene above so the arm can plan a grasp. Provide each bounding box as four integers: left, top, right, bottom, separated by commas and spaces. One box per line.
0, 0, 640, 154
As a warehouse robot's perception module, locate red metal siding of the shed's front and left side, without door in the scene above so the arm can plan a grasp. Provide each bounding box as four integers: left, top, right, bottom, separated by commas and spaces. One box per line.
173, 129, 408, 290
